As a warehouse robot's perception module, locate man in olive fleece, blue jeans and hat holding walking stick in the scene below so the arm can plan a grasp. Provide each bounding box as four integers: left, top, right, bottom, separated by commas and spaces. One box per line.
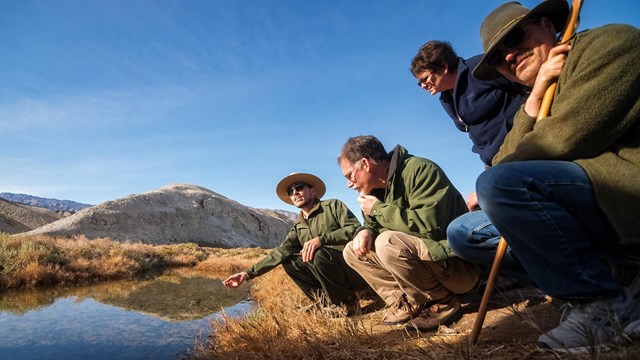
449, 0, 640, 351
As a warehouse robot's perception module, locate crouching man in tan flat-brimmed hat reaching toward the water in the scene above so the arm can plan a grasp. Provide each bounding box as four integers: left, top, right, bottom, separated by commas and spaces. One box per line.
223, 173, 366, 315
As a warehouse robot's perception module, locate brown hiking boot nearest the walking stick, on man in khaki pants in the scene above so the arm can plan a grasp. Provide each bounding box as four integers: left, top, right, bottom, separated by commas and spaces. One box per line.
405, 296, 462, 331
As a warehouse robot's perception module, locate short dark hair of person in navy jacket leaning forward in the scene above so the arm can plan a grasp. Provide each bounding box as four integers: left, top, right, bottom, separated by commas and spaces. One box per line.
409, 40, 458, 77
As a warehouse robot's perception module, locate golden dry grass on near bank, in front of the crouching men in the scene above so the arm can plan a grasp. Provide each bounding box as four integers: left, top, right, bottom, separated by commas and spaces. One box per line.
193, 267, 458, 359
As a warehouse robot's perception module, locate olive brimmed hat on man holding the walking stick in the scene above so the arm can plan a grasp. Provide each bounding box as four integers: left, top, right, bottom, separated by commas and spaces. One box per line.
472, 0, 569, 80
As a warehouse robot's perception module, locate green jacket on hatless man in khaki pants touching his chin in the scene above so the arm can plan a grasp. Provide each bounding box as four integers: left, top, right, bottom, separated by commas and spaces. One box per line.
358, 145, 468, 261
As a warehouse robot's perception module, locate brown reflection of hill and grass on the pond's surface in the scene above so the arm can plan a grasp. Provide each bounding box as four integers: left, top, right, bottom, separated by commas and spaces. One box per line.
0, 275, 248, 321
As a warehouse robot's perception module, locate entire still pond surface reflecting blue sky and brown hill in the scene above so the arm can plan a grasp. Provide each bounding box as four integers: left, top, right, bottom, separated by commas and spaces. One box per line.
0, 273, 250, 359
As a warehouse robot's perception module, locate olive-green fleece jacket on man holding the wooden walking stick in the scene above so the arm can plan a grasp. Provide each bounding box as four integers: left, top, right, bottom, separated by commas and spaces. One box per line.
493, 25, 640, 245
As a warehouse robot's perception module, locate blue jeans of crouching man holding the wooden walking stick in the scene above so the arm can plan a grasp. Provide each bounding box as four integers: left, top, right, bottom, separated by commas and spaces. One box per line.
447, 161, 625, 301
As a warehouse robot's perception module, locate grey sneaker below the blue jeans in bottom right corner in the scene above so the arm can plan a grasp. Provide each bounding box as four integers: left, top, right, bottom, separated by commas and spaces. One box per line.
538, 288, 640, 353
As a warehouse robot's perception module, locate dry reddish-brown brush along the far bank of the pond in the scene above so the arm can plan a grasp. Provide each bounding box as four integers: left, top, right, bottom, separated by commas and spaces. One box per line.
0, 234, 208, 289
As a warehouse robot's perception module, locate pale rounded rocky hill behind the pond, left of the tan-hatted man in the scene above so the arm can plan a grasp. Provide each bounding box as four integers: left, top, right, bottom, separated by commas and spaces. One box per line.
26, 184, 293, 248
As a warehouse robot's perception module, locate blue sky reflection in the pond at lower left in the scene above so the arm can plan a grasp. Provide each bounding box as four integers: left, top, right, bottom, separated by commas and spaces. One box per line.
0, 274, 250, 360
